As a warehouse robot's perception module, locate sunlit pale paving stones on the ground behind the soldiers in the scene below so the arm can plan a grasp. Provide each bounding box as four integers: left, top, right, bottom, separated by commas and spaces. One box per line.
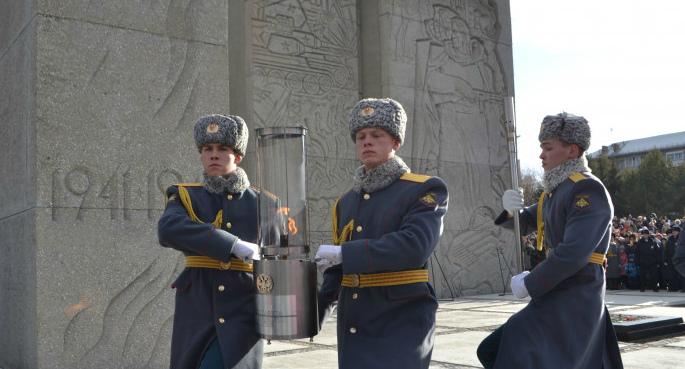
263, 291, 685, 369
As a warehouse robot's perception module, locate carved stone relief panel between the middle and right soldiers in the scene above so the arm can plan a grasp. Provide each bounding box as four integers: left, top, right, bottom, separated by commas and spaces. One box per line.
389, 0, 515, 297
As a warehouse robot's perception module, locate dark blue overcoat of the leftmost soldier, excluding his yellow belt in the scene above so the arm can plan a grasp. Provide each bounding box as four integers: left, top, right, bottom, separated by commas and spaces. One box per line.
158, 184, 263, 369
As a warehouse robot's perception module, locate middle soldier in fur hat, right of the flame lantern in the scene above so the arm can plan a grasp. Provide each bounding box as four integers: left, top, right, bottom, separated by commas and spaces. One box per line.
315, 99, 448, 369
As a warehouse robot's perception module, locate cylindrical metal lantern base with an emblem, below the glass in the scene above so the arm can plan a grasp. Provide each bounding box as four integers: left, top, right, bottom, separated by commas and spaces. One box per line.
254, 259, 319, 340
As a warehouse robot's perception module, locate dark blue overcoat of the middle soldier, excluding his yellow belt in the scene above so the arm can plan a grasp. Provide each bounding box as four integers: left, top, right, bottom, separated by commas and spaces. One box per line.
319, 175, 448, 369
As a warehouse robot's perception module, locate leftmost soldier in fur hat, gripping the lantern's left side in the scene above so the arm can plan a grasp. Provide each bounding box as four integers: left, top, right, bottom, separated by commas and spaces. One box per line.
158, 114, 263, 369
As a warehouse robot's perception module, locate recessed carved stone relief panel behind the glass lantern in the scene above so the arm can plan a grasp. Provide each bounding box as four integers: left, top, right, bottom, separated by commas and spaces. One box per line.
252, 0, 359, 242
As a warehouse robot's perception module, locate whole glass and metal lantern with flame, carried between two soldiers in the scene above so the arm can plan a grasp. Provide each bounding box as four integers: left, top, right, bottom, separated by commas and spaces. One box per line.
254, 127, 318, 339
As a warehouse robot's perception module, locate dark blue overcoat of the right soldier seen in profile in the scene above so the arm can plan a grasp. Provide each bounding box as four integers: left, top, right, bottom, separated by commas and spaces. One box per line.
494, 173, 623, 369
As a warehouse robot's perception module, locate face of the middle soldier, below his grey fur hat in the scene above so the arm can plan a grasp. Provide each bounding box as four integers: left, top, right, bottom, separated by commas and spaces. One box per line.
355, 128, 400, 169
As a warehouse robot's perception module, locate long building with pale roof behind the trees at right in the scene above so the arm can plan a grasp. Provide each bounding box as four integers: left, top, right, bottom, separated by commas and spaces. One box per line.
589, 131, 685, 171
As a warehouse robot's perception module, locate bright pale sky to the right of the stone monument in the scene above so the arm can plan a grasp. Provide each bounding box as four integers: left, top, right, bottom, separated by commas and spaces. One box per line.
510, 0, 685, 172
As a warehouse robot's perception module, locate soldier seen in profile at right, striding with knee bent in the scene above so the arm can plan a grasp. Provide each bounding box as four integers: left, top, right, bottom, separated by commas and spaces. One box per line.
477, 113, 623, 369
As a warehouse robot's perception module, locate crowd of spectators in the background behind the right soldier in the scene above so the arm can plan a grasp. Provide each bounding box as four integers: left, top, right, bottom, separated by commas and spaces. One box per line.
524, 213, 685, 292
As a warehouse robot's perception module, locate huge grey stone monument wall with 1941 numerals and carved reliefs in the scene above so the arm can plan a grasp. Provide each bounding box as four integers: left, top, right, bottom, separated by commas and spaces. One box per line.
0, 0, 514, 369
